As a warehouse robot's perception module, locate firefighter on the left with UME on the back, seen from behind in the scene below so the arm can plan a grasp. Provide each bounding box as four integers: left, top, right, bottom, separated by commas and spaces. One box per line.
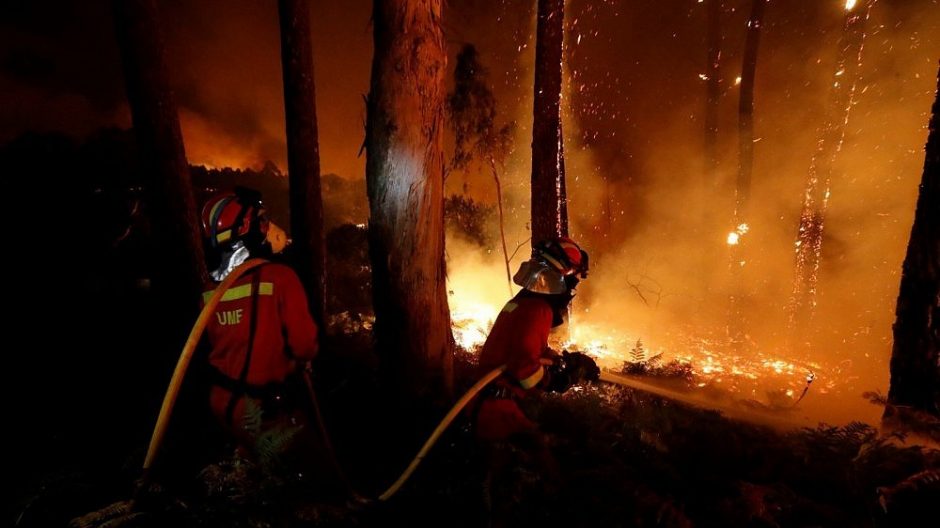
202, 188, 323, 480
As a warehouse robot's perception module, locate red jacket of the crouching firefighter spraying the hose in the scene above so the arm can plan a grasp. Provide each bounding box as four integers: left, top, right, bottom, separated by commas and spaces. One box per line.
476, 296, 552, 440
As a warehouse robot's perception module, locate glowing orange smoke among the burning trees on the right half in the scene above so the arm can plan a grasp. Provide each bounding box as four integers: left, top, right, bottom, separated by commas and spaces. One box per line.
449, 0, 940, 421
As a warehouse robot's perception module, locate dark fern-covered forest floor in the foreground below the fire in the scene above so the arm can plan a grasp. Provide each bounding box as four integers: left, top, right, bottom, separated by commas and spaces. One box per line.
12, 334, 940, 528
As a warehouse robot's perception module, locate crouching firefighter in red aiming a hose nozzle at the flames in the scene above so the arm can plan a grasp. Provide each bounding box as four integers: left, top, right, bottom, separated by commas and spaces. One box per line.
474, 237, 600, 517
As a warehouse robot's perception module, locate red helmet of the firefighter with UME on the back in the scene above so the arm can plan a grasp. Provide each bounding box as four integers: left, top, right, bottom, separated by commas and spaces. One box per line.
202, 188, 269, 247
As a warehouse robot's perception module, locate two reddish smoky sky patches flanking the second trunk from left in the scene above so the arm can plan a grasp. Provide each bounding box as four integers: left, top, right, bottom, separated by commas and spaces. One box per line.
161, 0, 372, 179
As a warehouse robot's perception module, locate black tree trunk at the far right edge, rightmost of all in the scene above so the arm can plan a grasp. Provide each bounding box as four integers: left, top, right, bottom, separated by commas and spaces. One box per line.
885, 65, 940, 418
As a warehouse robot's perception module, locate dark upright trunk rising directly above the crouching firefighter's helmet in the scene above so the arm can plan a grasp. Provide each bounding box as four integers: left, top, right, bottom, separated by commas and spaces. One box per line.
532, 0, 568, 244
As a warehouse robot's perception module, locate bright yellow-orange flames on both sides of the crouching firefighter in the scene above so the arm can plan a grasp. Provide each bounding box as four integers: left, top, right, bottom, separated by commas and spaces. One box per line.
448, 239, 848, 416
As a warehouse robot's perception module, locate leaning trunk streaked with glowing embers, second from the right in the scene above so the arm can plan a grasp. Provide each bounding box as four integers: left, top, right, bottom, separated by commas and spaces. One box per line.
789, 0, 877, 334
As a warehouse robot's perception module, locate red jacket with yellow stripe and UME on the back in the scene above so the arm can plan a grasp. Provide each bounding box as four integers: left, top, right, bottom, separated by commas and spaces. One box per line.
203, 263, 318, 434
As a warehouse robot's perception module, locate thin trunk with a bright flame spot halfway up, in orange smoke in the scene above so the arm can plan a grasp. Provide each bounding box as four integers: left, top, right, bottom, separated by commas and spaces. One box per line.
728, 0, 768, 346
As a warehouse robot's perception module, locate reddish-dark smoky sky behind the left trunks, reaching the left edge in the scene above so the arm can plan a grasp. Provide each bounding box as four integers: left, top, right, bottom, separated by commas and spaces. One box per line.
0, 0, 372, 179
